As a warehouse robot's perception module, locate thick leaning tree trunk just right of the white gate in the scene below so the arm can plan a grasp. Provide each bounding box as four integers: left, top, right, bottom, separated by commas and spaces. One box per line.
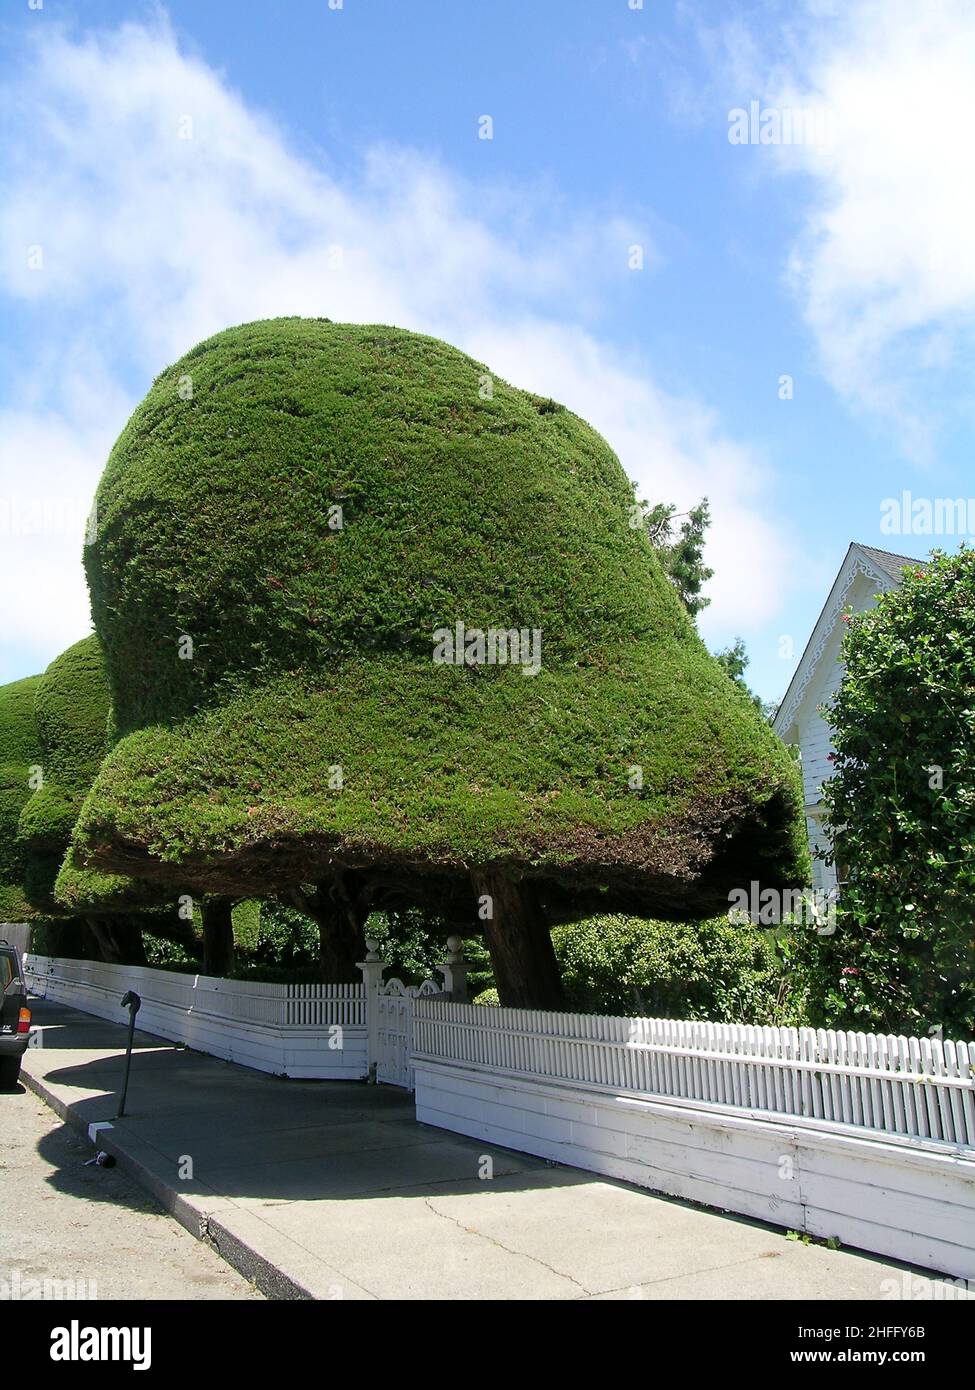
472, 869, 563, 1009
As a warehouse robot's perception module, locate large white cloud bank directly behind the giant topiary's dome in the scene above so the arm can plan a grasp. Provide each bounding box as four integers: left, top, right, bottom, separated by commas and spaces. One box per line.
0, 24, 789, 672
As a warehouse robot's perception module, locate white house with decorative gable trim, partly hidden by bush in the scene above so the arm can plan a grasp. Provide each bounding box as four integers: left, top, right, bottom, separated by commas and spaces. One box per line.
773, 541, 925, 892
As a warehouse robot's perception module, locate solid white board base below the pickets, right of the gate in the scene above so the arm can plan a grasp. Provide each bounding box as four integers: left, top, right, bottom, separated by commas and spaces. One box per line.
413, 1055, 975, 1298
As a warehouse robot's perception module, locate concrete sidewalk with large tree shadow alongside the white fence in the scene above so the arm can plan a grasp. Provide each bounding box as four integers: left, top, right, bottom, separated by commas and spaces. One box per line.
17, 999, 956, 1300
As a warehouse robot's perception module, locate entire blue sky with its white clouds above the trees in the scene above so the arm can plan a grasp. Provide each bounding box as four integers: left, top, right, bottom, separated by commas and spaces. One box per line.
0, 0, 975, 699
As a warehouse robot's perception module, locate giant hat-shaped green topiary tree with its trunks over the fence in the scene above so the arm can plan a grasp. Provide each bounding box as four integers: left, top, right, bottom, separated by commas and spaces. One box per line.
64, 318, 805, 1004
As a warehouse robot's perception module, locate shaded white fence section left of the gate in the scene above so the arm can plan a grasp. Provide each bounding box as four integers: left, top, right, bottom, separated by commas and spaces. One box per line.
24, 955, 369, 1080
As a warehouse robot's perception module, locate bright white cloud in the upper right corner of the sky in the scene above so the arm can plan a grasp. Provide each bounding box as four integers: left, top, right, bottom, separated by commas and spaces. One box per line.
705, 0, 975, 456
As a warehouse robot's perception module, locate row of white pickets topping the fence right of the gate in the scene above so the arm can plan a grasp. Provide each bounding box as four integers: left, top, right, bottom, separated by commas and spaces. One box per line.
413, 999, 975, 1145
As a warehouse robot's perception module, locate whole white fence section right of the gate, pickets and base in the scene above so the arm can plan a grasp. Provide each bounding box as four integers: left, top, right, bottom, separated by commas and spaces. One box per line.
412, 998, 975, 1280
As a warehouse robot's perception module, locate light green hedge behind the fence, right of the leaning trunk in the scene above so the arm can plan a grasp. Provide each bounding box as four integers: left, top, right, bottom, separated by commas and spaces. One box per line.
552, 916, 794, 1023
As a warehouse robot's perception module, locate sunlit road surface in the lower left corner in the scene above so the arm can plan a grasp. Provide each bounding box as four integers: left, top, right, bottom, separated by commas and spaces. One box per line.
0, 1086, 261, 1301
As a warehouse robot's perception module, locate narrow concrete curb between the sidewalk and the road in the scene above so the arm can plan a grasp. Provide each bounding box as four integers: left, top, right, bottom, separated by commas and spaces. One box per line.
21, 1056, 317, 1301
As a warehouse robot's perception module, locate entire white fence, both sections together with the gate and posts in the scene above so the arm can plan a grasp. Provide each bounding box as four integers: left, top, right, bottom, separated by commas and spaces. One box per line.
25, 938, 975, 1280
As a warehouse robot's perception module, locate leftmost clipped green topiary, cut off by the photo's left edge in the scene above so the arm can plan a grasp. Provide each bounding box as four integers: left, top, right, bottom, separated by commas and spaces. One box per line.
0, 676, 40, 922
